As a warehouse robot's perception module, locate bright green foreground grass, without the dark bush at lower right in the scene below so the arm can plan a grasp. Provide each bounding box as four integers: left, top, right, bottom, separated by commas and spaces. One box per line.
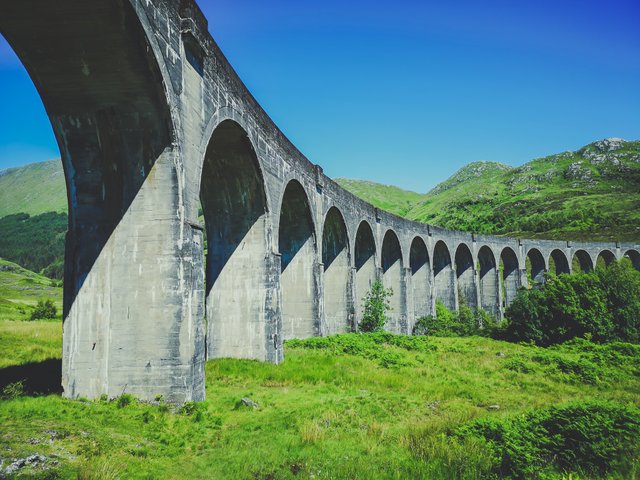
0, 321, 640, 479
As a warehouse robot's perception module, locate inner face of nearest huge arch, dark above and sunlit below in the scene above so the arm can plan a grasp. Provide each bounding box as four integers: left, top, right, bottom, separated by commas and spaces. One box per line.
0, 1, 204, 402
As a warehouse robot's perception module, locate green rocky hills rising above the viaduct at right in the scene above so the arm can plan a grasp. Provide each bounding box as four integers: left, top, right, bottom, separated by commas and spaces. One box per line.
341, 139, 640, 241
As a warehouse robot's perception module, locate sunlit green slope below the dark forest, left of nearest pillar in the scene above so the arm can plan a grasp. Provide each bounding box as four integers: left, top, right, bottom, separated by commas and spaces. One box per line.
0, 258, 62, 322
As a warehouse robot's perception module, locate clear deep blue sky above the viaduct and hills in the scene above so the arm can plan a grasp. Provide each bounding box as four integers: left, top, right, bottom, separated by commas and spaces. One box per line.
0, 0, 640, 192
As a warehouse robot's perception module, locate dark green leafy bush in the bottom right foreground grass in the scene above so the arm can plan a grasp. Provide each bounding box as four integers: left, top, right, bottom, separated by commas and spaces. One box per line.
453, 401, 640, 478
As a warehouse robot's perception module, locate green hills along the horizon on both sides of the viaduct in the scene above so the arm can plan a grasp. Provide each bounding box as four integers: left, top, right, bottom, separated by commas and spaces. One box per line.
0, 138, 640, 278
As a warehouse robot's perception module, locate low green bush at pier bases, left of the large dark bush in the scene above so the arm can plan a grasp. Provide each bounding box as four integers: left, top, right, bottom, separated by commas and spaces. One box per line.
413, 300, 498, 337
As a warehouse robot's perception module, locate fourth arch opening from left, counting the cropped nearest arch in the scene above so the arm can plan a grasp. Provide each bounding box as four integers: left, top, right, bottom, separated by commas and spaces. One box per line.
322, 207, 352, 335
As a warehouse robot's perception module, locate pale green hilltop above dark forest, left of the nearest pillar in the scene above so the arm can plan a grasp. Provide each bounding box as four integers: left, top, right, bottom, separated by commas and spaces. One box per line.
0, 160, 67, 218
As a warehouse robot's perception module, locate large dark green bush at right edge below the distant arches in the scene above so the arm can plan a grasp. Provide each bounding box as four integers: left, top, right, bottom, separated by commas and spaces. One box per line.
504, 260, 640, 346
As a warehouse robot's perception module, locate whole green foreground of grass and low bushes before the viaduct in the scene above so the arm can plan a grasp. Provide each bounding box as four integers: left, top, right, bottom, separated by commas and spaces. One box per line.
0, 320, 640, 480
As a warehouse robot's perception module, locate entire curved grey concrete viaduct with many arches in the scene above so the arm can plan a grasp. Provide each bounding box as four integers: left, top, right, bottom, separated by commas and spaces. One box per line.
0, 0, 640, 403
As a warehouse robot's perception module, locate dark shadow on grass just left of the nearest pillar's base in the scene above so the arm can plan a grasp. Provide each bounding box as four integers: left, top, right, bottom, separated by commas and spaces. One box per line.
0, 359, 62, 395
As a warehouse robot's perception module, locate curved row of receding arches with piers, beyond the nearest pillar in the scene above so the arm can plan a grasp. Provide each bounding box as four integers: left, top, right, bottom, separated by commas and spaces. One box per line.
200, 120, 640, 358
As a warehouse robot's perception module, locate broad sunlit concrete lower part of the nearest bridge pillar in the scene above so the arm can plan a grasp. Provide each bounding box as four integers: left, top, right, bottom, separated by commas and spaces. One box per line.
62, 150, 204, 403
